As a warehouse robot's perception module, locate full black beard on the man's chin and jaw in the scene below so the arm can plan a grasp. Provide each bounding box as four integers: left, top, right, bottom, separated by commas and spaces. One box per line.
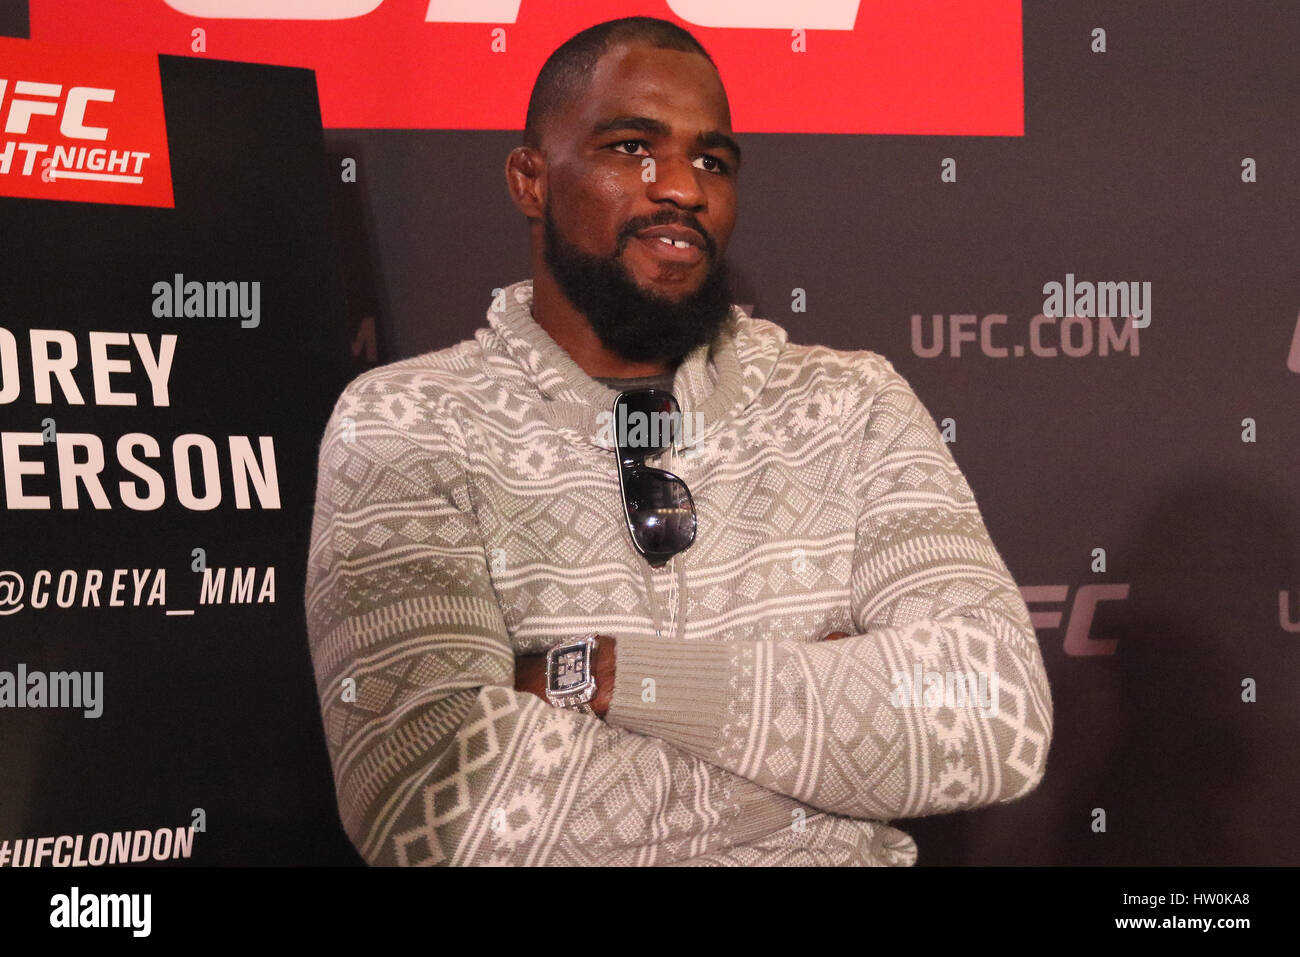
542, 207, 732, 367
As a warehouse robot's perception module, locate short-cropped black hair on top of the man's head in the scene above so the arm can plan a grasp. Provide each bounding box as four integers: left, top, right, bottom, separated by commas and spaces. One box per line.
524, 17, 718, 150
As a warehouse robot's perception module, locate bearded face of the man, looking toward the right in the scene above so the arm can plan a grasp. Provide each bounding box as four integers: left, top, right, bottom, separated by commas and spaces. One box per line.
542, 44, 740, 363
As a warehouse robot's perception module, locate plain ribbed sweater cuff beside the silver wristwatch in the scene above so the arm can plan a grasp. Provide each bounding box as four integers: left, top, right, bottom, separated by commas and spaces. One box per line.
605, 637, 736, 758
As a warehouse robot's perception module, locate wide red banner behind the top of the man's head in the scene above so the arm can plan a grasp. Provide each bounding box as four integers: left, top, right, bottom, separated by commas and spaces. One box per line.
30, 0, 1024, 137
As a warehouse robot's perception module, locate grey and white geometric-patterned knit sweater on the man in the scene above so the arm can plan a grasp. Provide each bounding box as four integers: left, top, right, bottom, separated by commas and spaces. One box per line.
306, 281, 1052, 865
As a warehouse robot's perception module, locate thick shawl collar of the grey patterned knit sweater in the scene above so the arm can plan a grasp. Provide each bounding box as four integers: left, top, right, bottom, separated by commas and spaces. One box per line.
475, 280, 787, 449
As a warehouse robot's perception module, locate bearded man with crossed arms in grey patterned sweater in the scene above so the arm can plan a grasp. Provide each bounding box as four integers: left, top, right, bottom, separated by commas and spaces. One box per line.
307, 17, 1052, 865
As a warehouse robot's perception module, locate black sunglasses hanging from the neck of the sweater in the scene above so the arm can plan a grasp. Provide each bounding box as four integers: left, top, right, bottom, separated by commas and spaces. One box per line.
614, 389, 696, 568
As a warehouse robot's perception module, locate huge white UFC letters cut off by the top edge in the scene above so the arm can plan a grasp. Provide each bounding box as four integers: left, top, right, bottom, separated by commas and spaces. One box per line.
164, 0, 861, 30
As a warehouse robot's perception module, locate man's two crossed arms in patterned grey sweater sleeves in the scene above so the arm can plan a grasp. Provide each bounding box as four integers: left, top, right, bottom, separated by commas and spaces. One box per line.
307, 367, 1052, 863
